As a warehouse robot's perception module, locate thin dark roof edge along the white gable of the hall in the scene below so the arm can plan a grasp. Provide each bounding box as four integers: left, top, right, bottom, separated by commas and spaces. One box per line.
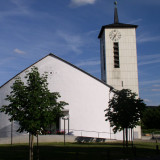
0, 53, 113, 89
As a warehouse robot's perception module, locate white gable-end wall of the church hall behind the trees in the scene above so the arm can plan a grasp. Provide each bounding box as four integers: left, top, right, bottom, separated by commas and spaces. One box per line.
0, 55, 122, 139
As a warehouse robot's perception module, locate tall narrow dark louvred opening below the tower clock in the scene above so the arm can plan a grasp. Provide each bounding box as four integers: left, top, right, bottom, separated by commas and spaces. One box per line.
113, 42, 120, 68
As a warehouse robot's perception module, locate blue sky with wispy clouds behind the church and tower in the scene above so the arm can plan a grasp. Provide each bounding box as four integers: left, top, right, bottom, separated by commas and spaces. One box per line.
0, 0, 160, 105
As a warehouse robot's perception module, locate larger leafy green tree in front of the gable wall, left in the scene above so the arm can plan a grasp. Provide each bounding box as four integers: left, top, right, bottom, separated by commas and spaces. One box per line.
0, 67, 67, 160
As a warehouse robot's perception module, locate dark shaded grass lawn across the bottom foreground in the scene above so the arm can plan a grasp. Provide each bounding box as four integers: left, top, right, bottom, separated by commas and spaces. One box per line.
0, 141, 160, 160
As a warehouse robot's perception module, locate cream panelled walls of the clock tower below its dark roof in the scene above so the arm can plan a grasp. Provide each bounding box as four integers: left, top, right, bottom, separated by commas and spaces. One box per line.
100, 28, 139, 94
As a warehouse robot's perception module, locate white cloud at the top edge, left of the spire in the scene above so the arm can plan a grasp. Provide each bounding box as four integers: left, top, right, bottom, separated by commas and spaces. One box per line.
70, 0, 97, 7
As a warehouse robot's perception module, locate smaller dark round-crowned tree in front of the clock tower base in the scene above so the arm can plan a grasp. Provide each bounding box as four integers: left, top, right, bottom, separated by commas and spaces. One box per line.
105, 89, 145, 146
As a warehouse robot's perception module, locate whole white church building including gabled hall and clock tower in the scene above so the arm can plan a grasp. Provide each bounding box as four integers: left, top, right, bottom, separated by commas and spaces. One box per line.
0, 2, 141, 139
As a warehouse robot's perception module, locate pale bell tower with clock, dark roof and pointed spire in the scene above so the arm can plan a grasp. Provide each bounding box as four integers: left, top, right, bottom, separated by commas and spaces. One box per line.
98, 2, 139, 94
